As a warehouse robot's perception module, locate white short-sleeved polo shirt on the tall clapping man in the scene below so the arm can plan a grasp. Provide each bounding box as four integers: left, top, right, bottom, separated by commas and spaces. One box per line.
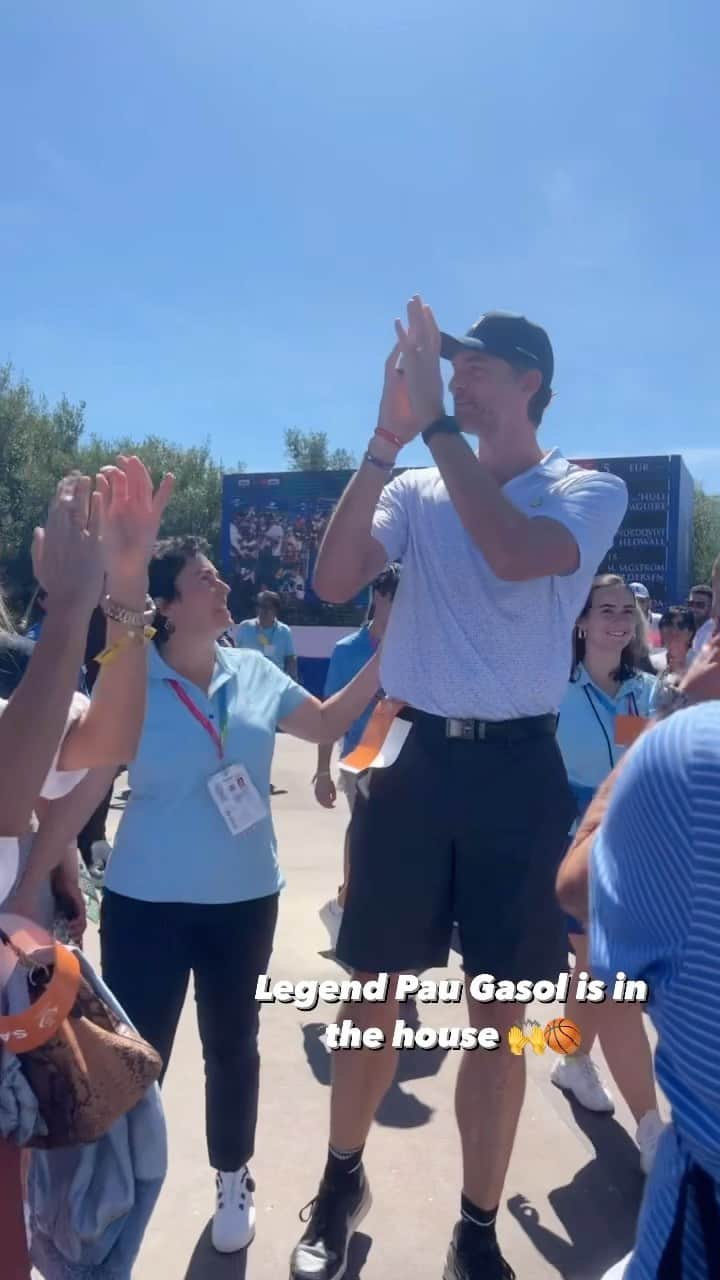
373, 449, 628, 721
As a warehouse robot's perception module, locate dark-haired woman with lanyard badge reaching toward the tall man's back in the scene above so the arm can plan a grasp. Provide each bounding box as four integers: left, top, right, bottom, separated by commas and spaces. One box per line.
101, 539, 378, 1253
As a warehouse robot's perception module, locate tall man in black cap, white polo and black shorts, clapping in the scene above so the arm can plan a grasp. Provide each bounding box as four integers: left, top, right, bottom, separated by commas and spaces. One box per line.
291, 297, 626, 1280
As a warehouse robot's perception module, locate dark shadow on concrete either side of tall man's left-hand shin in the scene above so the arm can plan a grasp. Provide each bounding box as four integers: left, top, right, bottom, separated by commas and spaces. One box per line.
302, 1000, 448, 1129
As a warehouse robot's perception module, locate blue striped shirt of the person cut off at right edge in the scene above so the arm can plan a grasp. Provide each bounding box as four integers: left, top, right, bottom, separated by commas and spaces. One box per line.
591, 703, 720, 1280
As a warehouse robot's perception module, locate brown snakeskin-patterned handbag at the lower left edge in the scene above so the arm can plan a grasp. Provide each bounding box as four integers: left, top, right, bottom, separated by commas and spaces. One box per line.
0, 931, 163, 1148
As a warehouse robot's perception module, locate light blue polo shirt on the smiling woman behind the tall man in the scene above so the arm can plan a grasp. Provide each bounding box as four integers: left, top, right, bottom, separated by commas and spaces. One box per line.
557, 663, 655, 813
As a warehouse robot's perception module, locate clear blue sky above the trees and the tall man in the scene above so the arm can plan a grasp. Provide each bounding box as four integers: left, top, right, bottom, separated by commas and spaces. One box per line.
0, 0, 720, 490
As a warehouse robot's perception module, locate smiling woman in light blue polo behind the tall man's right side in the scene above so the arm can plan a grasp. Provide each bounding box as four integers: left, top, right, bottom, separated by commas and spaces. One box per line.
552, 573, 662, 1172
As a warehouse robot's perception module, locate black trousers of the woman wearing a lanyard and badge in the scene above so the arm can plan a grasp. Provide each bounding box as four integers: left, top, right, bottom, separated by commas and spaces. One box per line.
100, 890, 278, 1172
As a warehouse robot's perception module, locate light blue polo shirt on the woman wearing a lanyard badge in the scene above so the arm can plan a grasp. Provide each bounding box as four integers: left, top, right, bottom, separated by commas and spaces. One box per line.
105, 645, 309, 902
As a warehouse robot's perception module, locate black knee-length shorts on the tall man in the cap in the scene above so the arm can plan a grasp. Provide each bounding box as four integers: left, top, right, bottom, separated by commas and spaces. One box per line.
337, 717, 575, 982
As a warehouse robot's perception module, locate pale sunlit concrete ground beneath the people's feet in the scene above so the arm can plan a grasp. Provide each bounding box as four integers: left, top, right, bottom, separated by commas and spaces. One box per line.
90, 737, 643, 1280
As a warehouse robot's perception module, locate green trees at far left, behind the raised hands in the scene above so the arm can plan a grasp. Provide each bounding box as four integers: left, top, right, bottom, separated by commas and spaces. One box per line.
0, 365, 242, 602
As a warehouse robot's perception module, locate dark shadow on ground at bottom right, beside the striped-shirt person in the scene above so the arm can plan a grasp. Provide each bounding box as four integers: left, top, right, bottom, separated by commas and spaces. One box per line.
507, 1101, 644, 1280
